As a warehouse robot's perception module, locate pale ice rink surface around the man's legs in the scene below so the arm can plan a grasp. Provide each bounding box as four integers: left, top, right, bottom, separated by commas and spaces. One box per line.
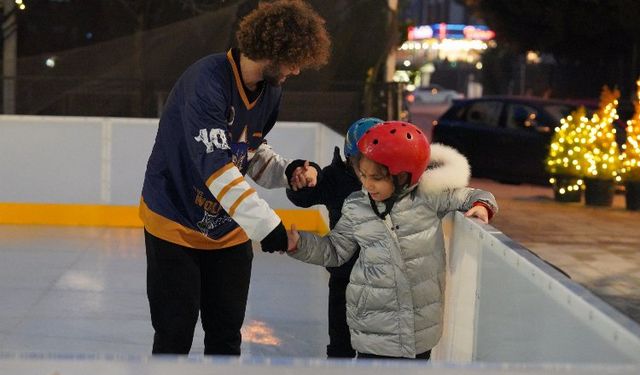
0, 225, 328, 358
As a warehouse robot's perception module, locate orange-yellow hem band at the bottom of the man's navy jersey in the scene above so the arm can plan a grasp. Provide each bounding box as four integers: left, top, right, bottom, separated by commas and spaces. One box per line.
140, 199, 249, 250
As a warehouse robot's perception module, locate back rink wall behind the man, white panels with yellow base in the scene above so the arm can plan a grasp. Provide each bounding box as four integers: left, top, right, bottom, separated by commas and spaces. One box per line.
0, 115, 343, 232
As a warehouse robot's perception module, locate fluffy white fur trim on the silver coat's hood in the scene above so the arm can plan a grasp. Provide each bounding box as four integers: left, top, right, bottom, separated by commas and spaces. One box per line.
418, 143, 471, 194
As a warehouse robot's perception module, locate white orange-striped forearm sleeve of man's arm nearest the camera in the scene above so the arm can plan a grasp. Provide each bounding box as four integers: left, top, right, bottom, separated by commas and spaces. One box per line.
206, 163, 280, 241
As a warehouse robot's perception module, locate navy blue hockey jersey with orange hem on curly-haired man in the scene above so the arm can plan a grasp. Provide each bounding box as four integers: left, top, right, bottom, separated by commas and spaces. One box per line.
140, 51, 281, 249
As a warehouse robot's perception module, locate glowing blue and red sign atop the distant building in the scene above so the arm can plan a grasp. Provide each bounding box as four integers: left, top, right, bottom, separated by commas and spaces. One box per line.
407, 23, 496, 40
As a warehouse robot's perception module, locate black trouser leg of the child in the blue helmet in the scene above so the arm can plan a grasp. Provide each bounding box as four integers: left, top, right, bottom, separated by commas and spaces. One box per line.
327, 274, 356, 358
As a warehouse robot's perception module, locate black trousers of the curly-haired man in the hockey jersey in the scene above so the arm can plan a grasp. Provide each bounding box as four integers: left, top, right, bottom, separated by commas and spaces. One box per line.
145, 230, 253, 355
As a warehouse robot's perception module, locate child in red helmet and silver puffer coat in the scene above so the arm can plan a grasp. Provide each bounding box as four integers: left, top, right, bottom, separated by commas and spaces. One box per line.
288, 121, 498, 359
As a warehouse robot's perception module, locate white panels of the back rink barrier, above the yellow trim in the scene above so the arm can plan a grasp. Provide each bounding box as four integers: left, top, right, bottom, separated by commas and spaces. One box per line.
0, 115, 344, 208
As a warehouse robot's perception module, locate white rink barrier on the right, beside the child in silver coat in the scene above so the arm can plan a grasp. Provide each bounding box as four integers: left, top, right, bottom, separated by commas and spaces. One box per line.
434, 213, 640, 366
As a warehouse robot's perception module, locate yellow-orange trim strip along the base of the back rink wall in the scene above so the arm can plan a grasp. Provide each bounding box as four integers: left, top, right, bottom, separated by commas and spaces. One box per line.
0, 203, 329, 234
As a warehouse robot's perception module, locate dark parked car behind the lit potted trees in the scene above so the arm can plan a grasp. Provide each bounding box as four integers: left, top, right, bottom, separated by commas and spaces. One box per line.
432, 96, 624, 185
